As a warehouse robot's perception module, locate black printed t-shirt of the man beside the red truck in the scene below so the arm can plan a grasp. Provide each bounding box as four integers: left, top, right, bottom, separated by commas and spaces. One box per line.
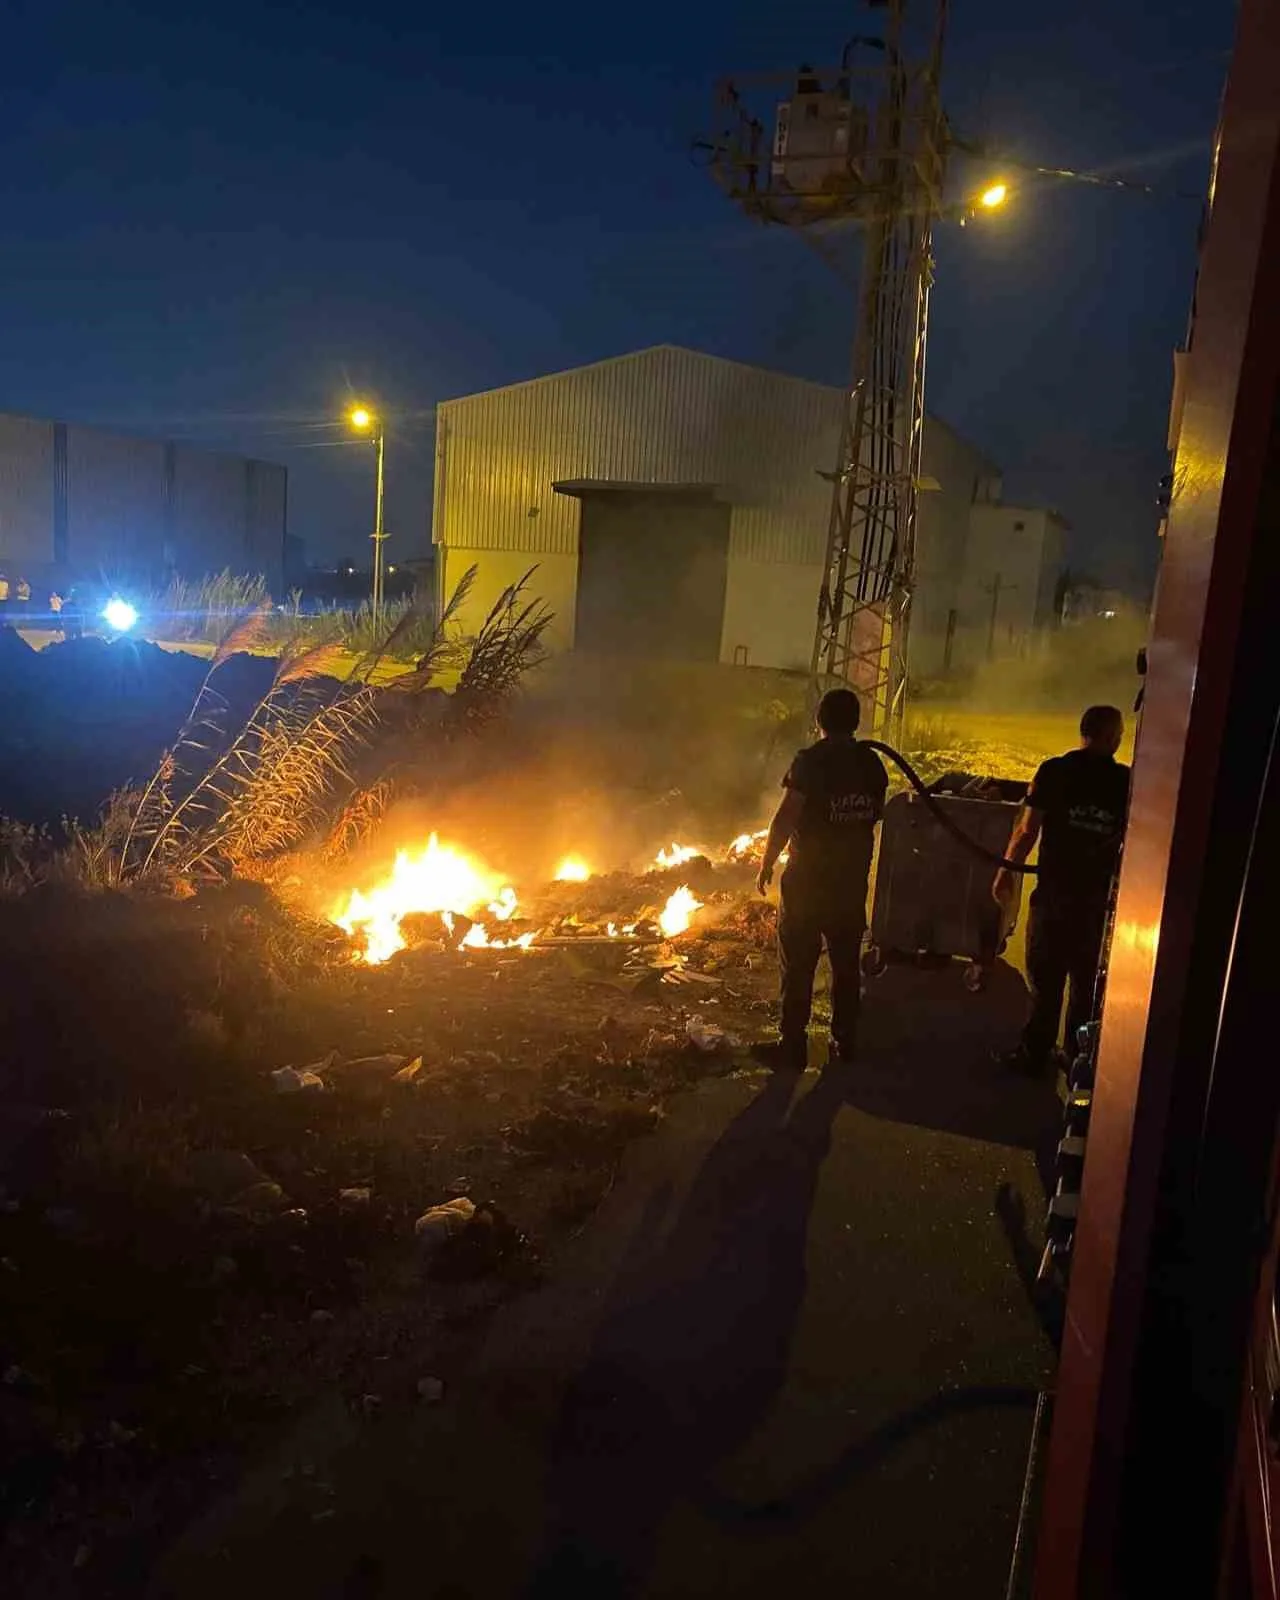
1027, 750, 1130, 902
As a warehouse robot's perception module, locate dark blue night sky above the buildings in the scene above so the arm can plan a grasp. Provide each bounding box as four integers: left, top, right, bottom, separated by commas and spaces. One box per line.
0, 0, 1234, 581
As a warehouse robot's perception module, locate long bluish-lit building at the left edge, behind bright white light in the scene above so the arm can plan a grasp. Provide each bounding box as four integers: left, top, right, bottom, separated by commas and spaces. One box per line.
0, 414, 288, 592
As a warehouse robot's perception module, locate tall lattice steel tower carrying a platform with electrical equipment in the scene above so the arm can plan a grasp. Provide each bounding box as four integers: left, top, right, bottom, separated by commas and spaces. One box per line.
701, 0, 947, 730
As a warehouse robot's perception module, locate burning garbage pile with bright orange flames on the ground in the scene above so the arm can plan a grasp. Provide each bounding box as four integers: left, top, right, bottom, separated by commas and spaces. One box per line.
330, 830, 765, 966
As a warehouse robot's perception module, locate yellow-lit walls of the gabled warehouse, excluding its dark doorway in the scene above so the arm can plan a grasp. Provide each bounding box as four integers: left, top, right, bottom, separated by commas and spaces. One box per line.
432, 346, 1017, 669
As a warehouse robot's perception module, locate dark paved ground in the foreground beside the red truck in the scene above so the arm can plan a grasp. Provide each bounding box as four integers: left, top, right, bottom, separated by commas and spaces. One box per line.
155, 968, 1058, 1600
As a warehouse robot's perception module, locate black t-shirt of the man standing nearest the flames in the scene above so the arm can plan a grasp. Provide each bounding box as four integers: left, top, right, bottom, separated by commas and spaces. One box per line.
782, 738, 890, 886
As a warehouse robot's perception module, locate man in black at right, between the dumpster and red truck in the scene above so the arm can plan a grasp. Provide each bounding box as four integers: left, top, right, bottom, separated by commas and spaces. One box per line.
992, 706, 1130, 1074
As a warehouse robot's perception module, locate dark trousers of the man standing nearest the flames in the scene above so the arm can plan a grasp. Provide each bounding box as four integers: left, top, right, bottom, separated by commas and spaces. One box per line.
778, 869, 867, 1061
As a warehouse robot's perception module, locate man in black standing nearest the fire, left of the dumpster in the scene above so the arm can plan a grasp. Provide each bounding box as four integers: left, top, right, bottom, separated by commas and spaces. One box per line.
757, 690, 888, 1072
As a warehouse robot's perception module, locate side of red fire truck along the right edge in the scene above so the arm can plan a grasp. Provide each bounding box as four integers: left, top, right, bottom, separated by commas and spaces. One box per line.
1034, 0, 1280, 1600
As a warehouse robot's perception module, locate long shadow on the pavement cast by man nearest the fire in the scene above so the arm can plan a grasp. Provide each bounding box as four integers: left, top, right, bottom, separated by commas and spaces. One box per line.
530, 1070, 850, 1600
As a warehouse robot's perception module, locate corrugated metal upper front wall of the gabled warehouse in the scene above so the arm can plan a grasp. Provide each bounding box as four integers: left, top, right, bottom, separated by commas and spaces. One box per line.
434, 346, 843, 563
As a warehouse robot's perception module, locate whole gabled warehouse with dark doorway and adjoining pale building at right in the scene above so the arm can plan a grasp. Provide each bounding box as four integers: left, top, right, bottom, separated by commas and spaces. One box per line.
432, 346, 1061, 677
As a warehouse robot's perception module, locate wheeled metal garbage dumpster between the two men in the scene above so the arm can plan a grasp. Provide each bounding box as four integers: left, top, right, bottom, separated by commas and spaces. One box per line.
862, 773, 1026, 989
